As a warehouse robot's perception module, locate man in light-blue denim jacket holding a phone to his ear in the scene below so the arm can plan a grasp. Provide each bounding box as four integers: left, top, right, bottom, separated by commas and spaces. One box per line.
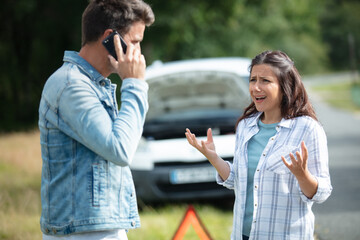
39, 0, 154, 240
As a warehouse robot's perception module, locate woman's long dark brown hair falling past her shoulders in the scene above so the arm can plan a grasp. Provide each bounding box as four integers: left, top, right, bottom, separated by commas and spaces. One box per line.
236, 51, 317, 126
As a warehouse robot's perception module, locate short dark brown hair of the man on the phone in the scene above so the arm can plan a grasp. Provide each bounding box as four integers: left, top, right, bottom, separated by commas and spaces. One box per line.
81, 0, 155, 46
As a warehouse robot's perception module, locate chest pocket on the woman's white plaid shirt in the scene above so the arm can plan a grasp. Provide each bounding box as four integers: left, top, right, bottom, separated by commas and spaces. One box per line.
266, 145, 300, 174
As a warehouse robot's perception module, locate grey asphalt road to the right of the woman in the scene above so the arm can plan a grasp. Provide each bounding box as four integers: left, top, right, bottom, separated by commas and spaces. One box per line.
304, 77, 360, 240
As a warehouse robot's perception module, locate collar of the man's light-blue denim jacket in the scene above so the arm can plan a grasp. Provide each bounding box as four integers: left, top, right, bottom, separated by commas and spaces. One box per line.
63, 51, 108, 84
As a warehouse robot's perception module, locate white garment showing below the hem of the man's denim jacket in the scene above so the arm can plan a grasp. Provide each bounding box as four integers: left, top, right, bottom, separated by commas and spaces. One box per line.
43, 229, 128, 240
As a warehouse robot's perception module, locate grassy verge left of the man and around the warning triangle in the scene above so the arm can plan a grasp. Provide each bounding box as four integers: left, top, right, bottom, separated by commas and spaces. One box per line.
0, 131, 232, 240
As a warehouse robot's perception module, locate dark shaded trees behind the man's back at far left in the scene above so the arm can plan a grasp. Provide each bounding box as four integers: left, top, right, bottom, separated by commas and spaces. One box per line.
0, 0, 86, 131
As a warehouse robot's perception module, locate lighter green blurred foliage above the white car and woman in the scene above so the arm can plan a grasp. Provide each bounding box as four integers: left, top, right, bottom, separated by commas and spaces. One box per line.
143, 0, 327, 73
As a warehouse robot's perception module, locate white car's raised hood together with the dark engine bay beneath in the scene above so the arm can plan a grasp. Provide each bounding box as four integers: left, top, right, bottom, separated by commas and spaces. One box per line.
143, 58, 250, 140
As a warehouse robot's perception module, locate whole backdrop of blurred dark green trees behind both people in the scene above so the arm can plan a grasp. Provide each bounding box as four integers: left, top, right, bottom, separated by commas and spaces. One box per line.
0, 0, 360, 132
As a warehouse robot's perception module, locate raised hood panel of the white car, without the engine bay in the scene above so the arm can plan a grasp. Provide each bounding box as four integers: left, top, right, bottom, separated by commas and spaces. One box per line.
146, 58, 250, 121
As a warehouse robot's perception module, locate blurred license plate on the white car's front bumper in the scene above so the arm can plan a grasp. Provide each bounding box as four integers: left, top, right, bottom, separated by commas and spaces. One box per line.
170, 166, 216, 184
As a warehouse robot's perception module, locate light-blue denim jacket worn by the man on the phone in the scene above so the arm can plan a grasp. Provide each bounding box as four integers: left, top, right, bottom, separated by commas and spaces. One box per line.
39, 51, 148, 235
